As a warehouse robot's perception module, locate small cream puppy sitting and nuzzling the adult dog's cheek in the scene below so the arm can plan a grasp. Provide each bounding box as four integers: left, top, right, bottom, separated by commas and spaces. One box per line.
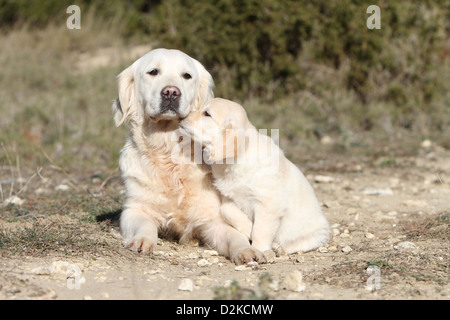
180, 98, 329, 254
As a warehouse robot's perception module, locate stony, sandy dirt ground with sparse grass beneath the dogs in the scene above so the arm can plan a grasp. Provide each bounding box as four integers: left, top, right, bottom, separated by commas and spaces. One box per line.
0, 143, 450, 300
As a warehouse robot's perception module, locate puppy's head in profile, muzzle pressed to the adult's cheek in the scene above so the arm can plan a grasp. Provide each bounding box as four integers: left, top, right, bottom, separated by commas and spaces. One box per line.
180, 98, 254, 163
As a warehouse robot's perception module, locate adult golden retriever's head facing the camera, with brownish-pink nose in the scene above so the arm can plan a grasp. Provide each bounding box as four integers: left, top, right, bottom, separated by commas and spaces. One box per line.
113, 49, 214, 126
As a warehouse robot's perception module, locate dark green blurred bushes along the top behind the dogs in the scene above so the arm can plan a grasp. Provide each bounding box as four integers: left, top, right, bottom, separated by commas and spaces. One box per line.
0, 0, 450, 145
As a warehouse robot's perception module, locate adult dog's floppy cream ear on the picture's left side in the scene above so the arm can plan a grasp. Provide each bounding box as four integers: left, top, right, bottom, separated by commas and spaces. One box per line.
112, 65, 136, 126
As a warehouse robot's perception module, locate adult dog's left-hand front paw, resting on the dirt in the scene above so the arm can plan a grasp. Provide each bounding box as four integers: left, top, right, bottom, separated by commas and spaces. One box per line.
120, 208, 158, 253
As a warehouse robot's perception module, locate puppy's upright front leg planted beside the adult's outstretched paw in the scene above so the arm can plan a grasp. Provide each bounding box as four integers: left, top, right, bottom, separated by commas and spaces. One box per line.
252, 205, 281, 252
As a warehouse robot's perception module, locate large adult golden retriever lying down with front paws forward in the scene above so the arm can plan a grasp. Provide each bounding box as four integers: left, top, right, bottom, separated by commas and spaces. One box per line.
113, 49, 264, 263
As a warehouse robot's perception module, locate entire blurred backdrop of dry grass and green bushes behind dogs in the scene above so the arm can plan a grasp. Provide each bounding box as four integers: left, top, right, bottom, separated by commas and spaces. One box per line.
0, 0, 450, 174
